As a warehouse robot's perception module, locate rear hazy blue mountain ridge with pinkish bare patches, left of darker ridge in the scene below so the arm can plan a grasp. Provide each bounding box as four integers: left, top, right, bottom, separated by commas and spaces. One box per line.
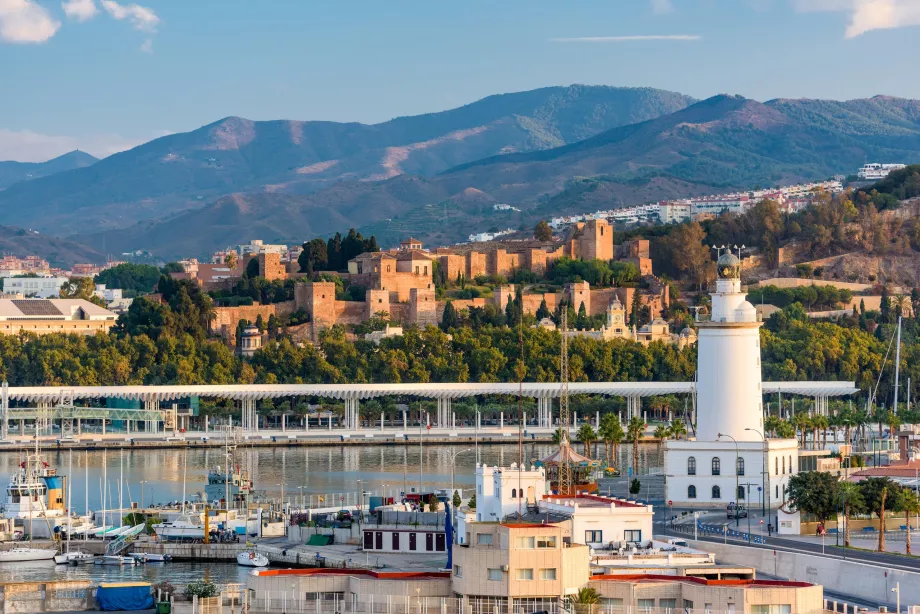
0, 86, 693, 232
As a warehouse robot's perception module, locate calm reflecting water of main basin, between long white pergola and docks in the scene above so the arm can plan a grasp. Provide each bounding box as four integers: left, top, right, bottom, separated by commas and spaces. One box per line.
0, 444, 662, 512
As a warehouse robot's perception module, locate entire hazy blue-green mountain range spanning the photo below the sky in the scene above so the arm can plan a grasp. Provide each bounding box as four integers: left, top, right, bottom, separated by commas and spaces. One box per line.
0, 85, 920, 258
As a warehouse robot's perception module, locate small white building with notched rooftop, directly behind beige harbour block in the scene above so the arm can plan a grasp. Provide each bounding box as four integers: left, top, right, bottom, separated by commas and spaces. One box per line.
476, 463, 546, 522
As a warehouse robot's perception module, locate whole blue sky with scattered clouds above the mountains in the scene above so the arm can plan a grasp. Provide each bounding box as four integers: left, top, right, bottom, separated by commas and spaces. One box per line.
0, 0, 920, 161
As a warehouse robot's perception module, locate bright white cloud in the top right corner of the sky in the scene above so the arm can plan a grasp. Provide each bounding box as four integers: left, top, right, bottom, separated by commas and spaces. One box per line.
793, 0, 920, 38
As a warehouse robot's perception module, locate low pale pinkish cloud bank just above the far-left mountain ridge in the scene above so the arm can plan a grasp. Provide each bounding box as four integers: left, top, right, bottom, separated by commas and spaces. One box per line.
0, 128, 146, 162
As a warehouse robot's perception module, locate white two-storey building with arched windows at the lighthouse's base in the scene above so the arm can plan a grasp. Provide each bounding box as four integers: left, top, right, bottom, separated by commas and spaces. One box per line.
664, 439, 798, 511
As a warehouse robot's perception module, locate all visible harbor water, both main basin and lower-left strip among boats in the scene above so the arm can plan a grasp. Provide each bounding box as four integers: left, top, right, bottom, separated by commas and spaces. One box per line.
0, 442, 662, 585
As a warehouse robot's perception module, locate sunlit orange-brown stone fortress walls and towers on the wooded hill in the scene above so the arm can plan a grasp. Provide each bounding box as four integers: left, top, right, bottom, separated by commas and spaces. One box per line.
203, 220, 677, 343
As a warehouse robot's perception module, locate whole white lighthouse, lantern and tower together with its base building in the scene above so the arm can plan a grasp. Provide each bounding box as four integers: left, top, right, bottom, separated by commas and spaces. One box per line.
665, 251, 798, 515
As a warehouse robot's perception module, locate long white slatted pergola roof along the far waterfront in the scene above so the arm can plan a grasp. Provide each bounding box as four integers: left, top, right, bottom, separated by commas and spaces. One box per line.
0, 382, 858, 437
